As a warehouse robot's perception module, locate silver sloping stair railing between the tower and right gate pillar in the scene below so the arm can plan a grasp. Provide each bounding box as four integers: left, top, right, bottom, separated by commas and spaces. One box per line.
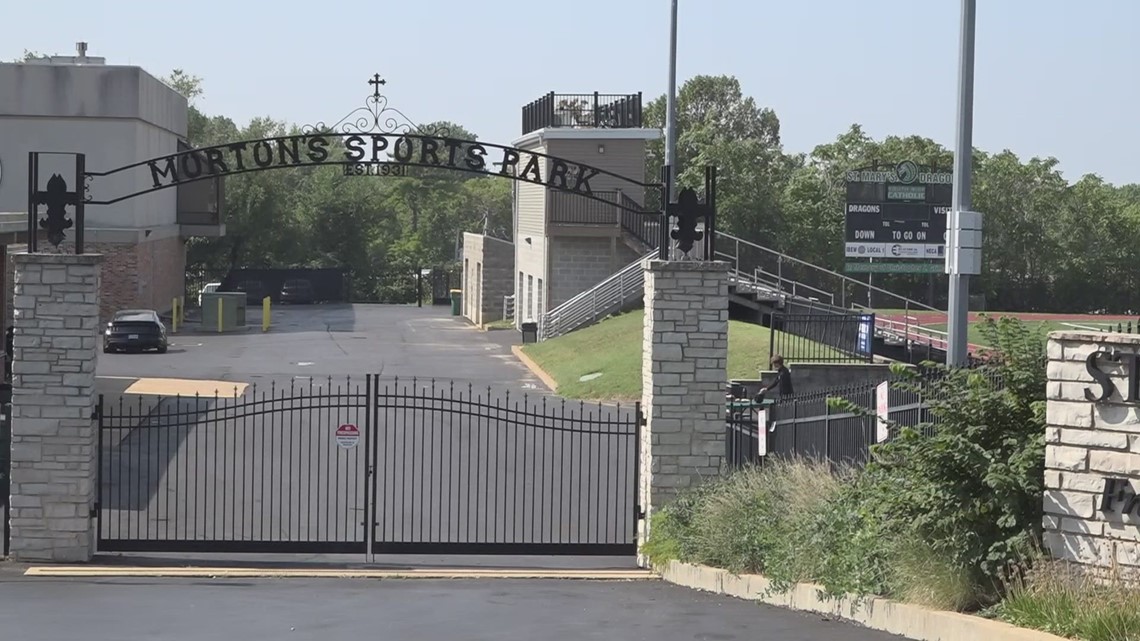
538, 250, 657, 341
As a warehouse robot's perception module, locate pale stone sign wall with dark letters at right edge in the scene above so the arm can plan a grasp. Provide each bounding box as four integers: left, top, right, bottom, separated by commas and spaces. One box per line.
1043, 332, 1140, 575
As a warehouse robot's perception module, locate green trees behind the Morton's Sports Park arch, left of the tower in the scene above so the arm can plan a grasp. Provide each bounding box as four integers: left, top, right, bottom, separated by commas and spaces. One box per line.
173, 70, 512, 301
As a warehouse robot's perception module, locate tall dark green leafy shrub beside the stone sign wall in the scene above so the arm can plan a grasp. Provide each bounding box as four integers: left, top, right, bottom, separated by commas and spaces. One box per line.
836, 318, 1045, 605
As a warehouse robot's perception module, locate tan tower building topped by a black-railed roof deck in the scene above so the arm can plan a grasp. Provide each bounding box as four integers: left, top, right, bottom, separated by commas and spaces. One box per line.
463, 92, 661, 325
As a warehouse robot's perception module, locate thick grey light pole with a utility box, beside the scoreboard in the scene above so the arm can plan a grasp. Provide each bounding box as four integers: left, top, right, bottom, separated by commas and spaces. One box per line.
946, 0, 982, 366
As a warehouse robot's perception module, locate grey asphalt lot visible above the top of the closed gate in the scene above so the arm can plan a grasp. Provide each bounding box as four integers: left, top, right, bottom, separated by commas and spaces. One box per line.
97, 305, 545, 393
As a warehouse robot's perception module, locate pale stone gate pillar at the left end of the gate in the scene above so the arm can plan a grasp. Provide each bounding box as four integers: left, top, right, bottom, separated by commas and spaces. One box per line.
11, 254, 101, 562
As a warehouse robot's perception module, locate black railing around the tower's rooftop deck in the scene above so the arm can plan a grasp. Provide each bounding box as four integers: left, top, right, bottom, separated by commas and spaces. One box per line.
522, 91, 642, 136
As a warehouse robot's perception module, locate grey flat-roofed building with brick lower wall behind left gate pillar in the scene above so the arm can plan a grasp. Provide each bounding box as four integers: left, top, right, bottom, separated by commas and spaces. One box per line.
0, 43, 225, 322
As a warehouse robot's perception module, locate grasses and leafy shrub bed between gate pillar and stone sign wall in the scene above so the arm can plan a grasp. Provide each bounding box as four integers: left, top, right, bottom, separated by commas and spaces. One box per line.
650, 318, 1045, 610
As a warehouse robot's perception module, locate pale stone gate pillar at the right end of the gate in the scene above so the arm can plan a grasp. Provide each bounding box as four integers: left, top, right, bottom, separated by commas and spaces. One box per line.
638, 260, 728, 556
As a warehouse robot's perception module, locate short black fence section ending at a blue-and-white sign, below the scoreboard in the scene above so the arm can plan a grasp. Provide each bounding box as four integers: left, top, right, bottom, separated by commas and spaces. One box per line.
770, 313, 874, 363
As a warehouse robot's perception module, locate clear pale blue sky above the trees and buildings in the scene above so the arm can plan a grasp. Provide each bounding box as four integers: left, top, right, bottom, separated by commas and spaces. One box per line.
0, 0, 1140, 184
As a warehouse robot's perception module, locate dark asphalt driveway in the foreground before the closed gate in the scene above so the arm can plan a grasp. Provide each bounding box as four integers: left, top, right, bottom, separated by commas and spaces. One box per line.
0, 578, 899, 641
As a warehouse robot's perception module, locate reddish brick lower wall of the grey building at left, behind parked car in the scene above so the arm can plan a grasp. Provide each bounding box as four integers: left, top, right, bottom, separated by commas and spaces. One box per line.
5, 236, 186, 326
